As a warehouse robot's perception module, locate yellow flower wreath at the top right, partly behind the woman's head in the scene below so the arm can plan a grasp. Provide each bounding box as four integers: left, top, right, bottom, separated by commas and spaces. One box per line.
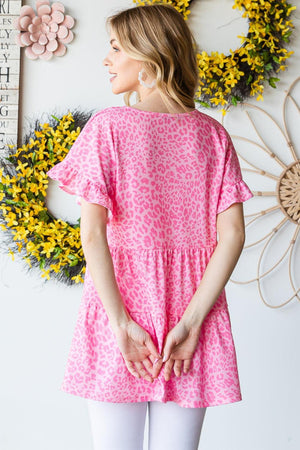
133, 0, 296, 112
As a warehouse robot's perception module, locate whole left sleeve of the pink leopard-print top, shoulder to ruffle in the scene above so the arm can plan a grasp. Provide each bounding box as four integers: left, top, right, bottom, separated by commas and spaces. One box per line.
47, 110, 115, 212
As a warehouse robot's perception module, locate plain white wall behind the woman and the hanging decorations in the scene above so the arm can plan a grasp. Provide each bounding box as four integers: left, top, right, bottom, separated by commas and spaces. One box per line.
0, 0, 300, 450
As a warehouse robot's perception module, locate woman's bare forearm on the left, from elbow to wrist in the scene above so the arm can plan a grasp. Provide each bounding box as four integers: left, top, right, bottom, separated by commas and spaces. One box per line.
81, 232, 130, 329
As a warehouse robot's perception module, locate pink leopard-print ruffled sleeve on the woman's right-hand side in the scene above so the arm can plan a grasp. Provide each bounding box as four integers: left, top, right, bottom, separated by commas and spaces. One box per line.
217, 133, 253, 214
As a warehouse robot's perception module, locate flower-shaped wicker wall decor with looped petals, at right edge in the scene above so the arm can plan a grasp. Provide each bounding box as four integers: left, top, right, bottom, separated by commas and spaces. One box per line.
223, 77, 300, 308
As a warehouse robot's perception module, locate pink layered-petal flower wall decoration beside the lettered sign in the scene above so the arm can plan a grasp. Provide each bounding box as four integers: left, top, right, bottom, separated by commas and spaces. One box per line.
14, 0, 75, 60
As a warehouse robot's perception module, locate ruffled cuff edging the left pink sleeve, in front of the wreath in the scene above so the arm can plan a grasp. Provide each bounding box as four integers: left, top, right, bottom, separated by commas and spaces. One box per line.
47, 163, 113, 211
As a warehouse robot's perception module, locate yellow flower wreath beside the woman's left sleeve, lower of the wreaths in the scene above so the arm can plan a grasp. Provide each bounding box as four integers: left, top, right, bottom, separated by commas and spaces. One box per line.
0, 112, 90, 284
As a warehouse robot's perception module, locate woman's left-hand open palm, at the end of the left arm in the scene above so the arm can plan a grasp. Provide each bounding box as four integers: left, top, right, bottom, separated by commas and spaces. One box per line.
114, 319, 162, 383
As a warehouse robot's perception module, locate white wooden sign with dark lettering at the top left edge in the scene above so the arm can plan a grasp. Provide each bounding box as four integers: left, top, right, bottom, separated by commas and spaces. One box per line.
0, 0, 21, 154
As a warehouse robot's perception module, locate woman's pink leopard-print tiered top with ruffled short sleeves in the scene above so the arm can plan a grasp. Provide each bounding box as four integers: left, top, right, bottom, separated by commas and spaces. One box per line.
48, 106, 253, 407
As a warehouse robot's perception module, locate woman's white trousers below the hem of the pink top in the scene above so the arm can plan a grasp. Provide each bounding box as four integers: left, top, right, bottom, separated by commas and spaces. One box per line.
87, 399, 206, 450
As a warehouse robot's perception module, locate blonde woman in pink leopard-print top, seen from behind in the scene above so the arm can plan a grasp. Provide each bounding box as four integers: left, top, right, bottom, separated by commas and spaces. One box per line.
49, 4, 252, 450
